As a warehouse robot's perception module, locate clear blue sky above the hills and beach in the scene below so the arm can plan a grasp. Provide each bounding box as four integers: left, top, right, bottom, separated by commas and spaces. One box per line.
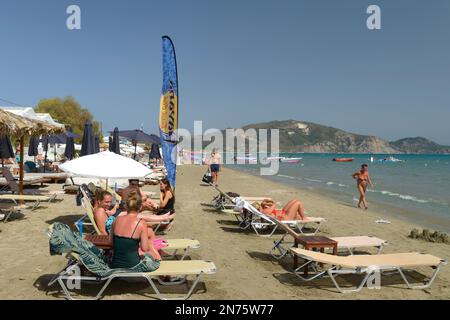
0, 0, 450, 144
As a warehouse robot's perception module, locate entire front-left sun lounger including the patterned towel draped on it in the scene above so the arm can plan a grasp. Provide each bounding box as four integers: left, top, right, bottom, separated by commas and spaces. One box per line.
48, 223, 216, 300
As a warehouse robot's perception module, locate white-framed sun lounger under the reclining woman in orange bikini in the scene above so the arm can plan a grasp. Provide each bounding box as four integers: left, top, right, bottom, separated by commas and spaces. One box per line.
235, 197, 326, 237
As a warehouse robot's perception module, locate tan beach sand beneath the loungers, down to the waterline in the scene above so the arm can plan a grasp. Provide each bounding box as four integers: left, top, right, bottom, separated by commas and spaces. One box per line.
0, 166, 450, 300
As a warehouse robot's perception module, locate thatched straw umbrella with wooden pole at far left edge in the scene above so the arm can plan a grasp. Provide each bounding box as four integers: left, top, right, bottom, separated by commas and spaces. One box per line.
0, 109, 65, 194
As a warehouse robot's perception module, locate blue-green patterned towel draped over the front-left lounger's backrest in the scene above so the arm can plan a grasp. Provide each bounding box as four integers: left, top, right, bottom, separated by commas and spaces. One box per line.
49, 222, 160, 277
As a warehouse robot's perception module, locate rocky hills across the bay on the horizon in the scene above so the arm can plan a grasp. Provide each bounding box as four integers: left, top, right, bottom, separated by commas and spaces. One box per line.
212, 120, 450, 154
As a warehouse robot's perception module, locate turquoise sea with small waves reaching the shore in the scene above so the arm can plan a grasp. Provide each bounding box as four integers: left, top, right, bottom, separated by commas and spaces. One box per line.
227, 153, 450, 232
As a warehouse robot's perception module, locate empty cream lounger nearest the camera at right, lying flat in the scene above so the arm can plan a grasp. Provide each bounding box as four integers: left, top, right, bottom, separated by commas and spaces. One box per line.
290, 248, 447, 293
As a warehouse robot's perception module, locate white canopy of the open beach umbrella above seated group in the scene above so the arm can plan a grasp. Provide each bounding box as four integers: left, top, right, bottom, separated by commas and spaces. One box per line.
59, 151, 152, 179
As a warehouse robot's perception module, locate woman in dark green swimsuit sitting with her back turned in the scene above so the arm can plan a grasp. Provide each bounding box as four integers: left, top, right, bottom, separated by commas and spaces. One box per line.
110, 192, 161, 268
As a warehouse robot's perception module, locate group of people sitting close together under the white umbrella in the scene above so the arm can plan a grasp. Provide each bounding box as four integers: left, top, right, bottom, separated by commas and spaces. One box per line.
93, 178, 175, 268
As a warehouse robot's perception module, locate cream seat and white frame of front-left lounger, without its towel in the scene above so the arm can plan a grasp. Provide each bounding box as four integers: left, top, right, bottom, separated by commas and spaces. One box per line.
48, 253, 217, 300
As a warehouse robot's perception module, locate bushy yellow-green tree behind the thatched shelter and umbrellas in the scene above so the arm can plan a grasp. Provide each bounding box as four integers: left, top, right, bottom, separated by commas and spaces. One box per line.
34, 97, 103, 141
